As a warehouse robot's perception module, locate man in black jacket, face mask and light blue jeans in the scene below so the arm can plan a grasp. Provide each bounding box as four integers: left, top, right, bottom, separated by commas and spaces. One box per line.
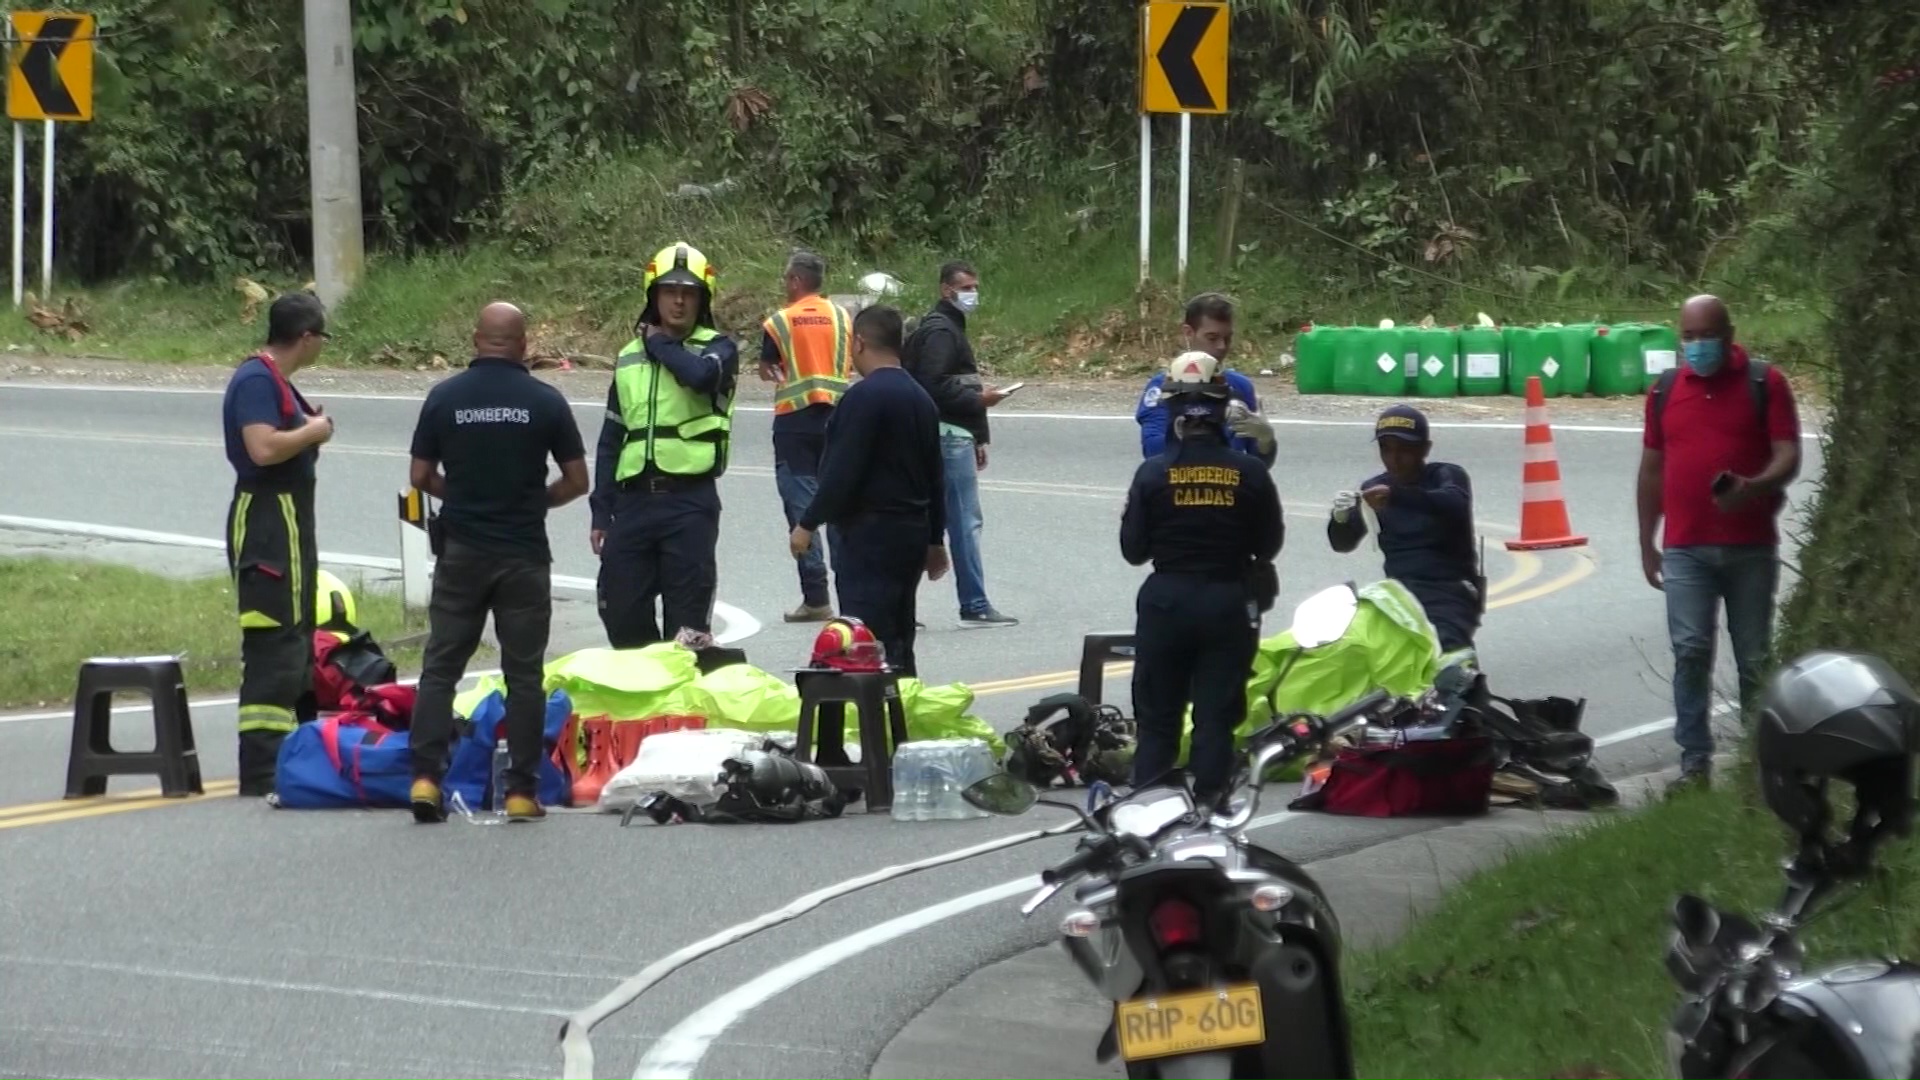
900, 261, 1018, 626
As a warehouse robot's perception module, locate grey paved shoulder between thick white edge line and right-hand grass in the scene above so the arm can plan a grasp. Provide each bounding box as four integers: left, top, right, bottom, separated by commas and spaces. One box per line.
870, 767, 1680, 1080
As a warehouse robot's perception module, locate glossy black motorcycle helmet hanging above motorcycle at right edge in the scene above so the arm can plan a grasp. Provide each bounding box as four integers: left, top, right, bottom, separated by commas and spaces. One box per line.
1753, 650, 1920, 838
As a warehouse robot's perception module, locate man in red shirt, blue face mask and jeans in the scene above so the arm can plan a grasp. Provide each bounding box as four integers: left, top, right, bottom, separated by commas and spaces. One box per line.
1638, 296, 1801, 784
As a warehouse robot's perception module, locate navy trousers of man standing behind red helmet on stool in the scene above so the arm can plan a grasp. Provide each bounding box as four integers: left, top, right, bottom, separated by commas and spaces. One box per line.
828, 515, 931, 678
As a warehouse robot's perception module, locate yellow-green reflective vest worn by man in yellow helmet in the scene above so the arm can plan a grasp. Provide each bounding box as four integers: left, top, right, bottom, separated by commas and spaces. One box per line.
612, 327, 733, 480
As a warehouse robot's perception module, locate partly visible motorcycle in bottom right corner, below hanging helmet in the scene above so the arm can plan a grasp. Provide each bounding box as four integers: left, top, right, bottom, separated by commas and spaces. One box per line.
1667, 791, 1920, 1080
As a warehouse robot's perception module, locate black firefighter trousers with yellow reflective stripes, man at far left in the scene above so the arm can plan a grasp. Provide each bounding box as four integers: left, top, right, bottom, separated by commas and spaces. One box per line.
227, 480, 321, 798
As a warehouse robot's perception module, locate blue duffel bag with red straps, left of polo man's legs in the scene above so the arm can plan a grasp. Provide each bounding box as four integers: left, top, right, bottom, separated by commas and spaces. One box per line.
275, 713, 413, 809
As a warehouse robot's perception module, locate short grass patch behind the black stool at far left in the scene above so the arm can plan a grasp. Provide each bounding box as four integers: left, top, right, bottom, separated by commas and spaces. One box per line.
0, 557, 445, 709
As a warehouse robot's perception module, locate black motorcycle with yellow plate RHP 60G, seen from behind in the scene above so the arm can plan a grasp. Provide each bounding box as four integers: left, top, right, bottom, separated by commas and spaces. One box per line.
964, 584, 1398, 1080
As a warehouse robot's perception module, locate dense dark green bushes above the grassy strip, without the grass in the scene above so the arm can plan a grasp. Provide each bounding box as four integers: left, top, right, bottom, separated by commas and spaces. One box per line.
61, 0, 1809, 284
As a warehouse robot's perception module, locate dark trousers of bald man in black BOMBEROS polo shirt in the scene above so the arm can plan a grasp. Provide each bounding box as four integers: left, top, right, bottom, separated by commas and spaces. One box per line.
409, 538, 553, 796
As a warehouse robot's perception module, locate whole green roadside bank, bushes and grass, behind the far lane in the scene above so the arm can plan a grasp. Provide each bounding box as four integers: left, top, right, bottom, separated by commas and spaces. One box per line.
0, 0, 1828, 373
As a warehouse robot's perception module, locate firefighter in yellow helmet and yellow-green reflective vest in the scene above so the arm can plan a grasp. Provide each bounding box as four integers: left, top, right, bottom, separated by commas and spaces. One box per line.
589, 242, 739, 650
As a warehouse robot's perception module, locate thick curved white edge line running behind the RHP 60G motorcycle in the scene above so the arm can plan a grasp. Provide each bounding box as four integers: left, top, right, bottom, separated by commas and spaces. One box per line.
610, 705, 1697, 1080
